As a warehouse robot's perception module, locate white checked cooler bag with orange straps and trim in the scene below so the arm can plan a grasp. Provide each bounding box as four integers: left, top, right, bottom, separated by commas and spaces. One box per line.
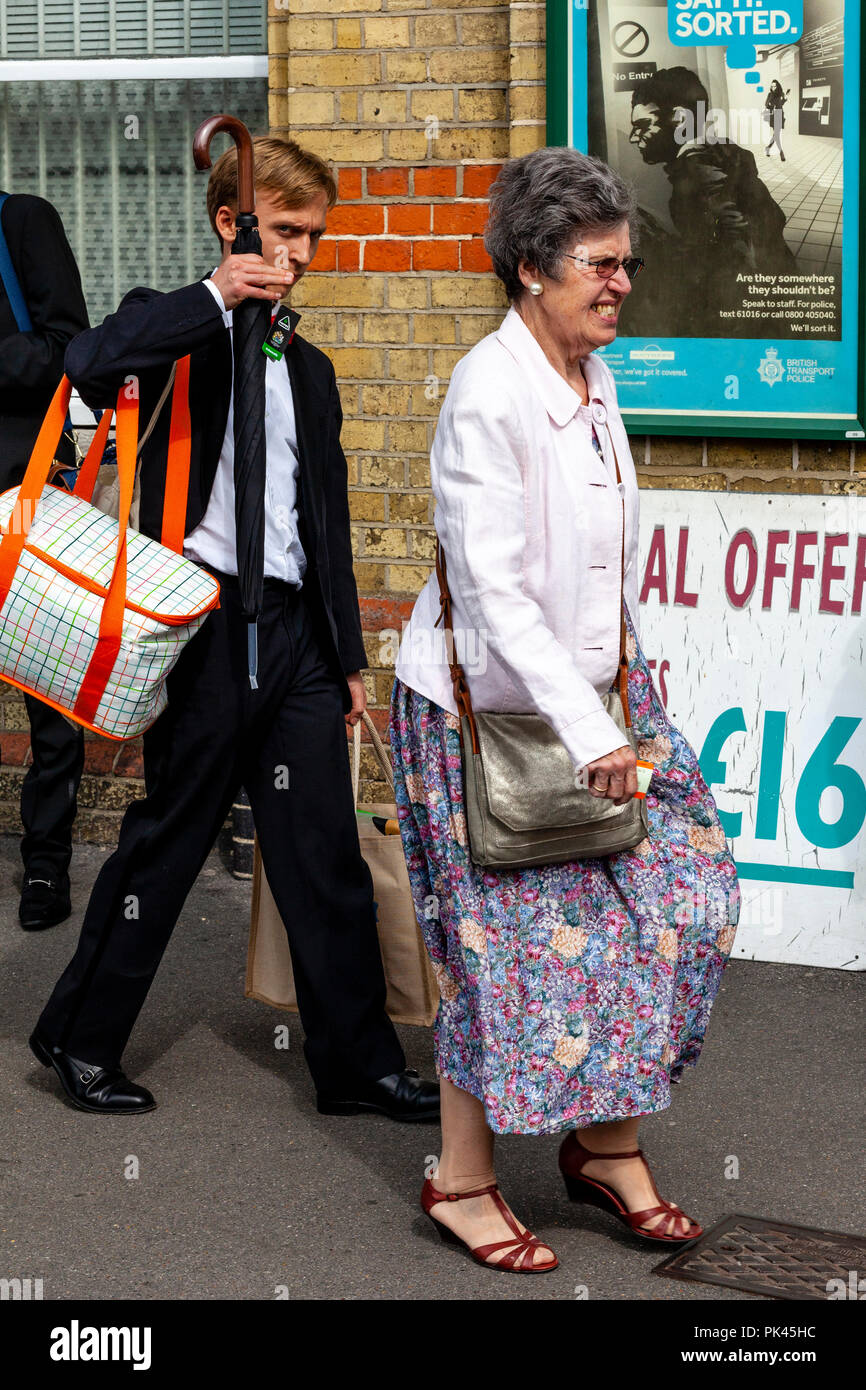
0, 357, 220, 738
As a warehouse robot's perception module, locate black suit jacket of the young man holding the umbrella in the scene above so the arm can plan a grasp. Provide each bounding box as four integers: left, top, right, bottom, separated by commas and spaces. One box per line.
65, 277, 367, 709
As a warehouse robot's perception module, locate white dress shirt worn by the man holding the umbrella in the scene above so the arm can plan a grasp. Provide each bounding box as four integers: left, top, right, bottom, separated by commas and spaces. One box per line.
183, 279, 307, 588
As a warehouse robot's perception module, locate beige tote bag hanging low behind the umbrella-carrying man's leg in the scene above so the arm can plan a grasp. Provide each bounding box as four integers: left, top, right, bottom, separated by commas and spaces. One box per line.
245, 712, 439, 1027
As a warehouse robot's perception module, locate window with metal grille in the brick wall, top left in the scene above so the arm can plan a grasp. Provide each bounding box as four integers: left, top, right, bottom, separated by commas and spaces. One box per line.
0, 0, 268, 322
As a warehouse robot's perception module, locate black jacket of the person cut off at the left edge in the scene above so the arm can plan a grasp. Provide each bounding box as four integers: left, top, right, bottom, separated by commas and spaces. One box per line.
0, 193, 88, 491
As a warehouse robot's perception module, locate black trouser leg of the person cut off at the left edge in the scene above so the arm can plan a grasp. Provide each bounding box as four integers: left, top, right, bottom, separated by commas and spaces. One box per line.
21, 695, 85, 878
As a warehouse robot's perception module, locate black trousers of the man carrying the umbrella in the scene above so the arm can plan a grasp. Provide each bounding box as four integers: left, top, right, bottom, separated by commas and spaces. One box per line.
39, 570, 406, 1094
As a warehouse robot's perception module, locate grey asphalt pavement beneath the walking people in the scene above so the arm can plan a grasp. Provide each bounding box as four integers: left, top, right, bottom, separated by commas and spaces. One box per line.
0, 835, 866, 1302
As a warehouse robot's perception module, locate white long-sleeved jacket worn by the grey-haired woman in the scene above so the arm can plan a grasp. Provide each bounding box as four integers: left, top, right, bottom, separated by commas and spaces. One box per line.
396, 307, 638, 767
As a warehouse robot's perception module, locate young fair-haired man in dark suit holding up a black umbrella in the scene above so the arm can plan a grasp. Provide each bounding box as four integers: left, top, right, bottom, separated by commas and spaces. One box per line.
31, 138, 439, 1119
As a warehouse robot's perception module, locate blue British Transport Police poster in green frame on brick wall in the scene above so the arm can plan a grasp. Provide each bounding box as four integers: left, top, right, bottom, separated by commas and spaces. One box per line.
548, 0, 866, 439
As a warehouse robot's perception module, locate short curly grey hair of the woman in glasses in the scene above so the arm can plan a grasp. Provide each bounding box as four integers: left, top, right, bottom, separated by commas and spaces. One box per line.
484, 146, 634, 299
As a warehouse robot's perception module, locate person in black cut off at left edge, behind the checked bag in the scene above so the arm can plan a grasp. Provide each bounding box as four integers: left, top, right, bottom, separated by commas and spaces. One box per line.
0, 193, 88, 931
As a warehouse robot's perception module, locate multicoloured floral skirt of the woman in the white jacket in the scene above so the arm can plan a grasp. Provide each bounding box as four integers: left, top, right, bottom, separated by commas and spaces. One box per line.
391, 603, 740, 1134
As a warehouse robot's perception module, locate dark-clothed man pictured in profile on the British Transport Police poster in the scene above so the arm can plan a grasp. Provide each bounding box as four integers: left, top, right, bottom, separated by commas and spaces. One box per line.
624, 68, 796, 336
